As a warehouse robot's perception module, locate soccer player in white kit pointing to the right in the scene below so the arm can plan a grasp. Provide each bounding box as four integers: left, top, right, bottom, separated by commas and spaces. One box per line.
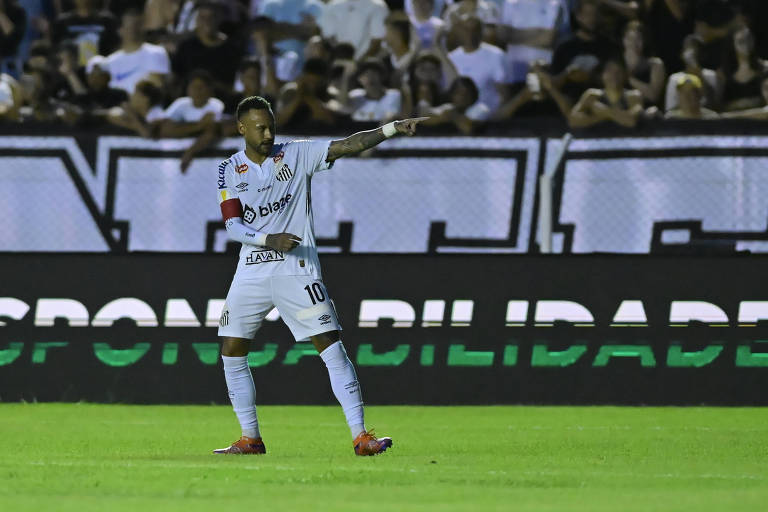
214, 96, 426, 455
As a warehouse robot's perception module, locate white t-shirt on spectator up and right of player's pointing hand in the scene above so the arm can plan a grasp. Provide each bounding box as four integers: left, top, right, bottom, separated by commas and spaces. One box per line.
448, 43, 507, 110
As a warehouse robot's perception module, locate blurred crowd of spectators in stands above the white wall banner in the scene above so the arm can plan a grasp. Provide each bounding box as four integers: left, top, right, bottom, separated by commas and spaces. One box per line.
0, 0, 768, 158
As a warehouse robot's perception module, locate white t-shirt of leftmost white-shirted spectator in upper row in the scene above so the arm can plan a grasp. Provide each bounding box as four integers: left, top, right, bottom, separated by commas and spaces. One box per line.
104, 43, 171, 94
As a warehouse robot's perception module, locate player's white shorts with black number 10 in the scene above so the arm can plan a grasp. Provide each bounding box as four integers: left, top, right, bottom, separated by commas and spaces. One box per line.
219, 275, 341, 341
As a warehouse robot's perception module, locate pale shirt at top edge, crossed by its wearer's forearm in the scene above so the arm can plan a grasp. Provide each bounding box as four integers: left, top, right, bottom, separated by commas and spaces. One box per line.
500, 0, 566, 82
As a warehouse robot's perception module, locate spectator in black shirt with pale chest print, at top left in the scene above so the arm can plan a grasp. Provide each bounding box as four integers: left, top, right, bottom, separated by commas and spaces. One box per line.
52, 0, 117, 66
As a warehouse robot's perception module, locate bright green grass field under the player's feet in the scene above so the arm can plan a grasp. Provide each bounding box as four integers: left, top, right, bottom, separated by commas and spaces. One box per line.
0, 404, 768, 512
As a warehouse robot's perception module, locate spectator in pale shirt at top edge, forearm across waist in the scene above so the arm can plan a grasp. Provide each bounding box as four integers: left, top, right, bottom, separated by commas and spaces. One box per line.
496, 0, 567, 83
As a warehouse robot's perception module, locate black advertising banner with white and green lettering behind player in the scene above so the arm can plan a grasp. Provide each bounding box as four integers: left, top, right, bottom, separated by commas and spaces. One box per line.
0, 253, 768, 405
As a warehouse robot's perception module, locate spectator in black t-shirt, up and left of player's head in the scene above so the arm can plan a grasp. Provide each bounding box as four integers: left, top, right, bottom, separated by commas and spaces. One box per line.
173, 1, 244, 92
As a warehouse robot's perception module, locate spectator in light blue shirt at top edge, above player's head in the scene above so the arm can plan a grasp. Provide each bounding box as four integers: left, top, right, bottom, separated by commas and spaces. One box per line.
261, 0, 323, 69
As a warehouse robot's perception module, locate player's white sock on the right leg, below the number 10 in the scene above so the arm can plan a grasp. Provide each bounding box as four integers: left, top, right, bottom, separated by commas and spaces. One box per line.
320, 341, 365, 439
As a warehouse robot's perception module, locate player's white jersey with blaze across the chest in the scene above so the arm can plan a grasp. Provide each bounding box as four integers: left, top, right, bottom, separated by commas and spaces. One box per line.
217, 140, 333, 279
